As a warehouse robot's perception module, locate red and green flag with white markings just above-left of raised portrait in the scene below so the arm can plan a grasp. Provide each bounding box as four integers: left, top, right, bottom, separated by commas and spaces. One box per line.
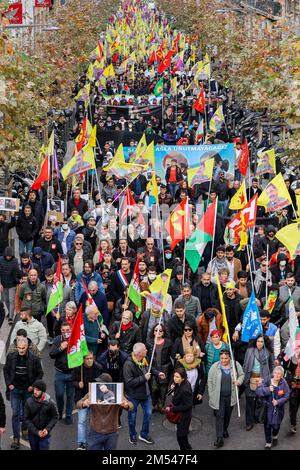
67, 305, 89, 369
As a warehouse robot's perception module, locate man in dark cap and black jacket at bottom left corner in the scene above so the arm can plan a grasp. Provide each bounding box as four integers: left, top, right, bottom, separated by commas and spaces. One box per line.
24, 380, 58, 450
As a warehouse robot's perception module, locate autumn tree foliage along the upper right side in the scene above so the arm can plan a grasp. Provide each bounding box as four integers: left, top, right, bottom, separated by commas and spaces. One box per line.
158, 0, 300, 165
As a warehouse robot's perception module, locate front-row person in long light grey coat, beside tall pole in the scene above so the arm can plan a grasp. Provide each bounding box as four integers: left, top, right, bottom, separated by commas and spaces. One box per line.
207, 348, 245, 448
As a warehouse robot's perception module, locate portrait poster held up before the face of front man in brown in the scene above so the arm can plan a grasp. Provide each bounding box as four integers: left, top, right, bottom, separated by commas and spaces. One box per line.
89, 382, 124, 405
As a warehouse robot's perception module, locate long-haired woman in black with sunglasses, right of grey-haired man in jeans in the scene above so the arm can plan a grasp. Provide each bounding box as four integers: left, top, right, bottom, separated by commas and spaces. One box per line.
146, 325, 173, 413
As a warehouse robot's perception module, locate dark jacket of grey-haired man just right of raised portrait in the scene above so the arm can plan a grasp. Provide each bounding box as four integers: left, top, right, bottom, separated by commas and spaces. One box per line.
123, 356, 150, 400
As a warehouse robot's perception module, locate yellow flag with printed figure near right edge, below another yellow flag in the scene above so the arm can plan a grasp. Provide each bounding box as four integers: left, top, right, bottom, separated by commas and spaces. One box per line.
257, 173, 292, 212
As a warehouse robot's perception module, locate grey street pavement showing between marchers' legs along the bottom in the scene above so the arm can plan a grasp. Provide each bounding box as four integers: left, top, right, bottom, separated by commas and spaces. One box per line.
0, 319, 300, 451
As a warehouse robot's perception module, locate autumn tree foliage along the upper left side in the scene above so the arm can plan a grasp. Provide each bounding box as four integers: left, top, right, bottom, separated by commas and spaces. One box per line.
0, 0, 119, 170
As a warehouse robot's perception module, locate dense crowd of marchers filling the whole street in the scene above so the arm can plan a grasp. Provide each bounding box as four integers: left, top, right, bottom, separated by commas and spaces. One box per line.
0, 0, 300, 450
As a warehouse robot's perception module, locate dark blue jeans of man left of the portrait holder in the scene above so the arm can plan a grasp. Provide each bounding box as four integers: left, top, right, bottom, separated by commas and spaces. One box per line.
54, 371, 75, 417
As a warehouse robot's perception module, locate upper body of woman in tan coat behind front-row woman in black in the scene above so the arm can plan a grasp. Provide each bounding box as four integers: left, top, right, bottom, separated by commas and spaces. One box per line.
172, 321, 205, 360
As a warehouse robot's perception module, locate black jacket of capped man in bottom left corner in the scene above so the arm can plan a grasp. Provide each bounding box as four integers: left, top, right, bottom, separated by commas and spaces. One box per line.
24, 394, 58, 436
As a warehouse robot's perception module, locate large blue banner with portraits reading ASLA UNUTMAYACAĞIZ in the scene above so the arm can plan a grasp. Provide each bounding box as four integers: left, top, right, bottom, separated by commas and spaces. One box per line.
124, 144, 234, 182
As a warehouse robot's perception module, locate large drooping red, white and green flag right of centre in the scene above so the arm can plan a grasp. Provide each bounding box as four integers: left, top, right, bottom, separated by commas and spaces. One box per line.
185, 199, 217, 273
